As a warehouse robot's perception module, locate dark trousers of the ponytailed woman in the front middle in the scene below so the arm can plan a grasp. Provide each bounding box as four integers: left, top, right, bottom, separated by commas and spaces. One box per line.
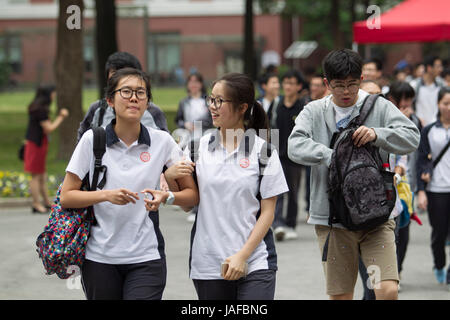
193, 270, 276, 300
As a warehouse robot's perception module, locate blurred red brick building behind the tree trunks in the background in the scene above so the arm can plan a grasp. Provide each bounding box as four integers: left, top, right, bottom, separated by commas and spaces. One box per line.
0, 0, 298, 84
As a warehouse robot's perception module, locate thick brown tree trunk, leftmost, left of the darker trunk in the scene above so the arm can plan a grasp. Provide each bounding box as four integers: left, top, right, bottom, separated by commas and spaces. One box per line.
55, 0, 84, 160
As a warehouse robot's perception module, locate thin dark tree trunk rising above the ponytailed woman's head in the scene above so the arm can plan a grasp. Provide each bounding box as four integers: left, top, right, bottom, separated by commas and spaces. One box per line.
244, 0, 256, 80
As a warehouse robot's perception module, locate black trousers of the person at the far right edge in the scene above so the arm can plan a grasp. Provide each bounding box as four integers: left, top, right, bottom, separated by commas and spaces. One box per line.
427, 192, 450, 272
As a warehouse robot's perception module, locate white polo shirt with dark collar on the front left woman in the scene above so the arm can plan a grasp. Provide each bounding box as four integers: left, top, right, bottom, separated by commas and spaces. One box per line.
66, 120, 182, 264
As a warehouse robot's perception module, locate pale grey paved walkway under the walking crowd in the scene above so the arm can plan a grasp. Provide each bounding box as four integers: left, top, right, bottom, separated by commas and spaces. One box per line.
0, 202, 450, 300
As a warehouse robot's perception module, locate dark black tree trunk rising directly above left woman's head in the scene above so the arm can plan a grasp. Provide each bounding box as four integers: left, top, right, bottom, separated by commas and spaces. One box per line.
95, 0, 117, 98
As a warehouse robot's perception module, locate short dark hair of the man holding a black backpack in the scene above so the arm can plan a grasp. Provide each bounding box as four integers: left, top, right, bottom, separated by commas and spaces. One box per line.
322, 49, 362, 82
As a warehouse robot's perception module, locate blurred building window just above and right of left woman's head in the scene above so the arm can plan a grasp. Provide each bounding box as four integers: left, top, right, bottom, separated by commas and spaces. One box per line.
148, 33, 181, 83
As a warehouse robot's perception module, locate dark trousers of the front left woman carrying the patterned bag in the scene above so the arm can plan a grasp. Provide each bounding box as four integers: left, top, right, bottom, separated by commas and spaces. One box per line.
81, 259, 167, 300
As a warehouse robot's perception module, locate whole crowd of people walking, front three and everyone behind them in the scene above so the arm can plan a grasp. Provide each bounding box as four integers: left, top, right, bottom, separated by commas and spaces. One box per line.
25, 49, 450, 300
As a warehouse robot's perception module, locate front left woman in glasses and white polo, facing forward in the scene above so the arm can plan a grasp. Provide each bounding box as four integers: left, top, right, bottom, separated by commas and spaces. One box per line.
61, 68, 198, 300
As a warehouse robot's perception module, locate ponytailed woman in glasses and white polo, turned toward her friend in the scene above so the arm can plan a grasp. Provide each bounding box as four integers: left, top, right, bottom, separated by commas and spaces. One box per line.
165, 73, 288, 300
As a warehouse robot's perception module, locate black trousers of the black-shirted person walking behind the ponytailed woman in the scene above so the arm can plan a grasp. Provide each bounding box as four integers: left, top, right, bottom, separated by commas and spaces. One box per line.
273, 159, 302, 228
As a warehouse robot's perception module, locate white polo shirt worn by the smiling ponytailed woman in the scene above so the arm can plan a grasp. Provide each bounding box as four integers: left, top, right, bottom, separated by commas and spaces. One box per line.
186, 131, 288, 280
